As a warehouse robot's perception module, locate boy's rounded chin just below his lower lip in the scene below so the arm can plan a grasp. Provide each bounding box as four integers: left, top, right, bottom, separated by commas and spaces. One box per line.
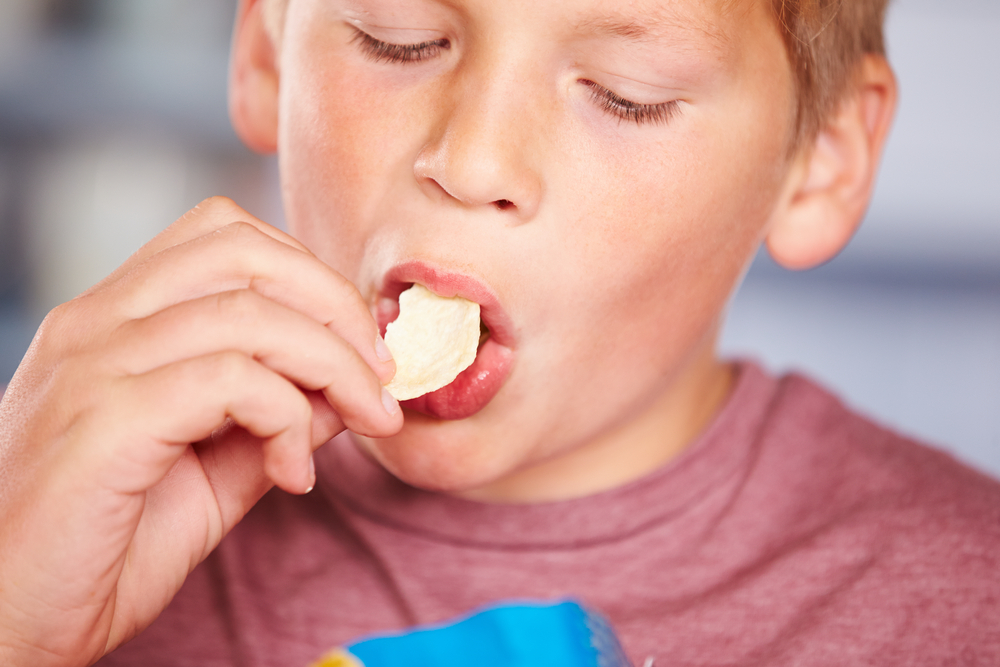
353, 410, 524, 493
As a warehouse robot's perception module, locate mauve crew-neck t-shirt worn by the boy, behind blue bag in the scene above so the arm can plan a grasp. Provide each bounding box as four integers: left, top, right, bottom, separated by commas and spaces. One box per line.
100, 364, 1000, 667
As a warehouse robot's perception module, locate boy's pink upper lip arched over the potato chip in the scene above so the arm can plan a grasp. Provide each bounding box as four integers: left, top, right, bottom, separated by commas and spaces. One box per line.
378, 261, 516, 348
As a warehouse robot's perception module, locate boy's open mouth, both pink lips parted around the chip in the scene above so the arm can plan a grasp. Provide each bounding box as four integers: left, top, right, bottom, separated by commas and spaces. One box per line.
376, 262, 514, 420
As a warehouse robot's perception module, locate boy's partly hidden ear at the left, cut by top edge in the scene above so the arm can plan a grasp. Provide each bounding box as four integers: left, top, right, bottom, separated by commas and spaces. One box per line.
229, 0, 279, 153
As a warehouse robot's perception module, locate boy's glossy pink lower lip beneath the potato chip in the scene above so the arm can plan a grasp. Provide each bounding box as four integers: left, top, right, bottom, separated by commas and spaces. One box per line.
401, 338, 513, 419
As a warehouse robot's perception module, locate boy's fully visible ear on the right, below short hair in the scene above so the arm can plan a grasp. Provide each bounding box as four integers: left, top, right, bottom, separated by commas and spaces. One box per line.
767, 55, 897, 269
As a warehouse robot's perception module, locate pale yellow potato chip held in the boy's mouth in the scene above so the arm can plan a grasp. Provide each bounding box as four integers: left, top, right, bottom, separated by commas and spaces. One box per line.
385, 284, 479, 401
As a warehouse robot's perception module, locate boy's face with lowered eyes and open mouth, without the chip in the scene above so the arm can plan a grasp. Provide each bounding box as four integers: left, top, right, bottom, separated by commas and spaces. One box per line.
279, 0, 794, 490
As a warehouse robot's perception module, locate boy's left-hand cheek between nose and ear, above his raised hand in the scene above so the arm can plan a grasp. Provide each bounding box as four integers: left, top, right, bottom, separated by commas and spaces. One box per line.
279, 34, 426, 277
